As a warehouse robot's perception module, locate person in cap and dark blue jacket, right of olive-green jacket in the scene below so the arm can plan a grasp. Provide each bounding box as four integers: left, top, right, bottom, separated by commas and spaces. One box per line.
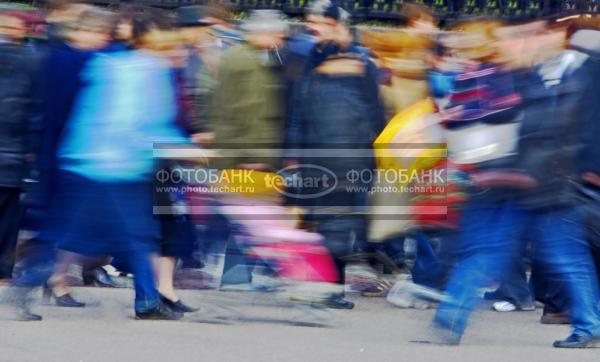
286, 0, 384, 309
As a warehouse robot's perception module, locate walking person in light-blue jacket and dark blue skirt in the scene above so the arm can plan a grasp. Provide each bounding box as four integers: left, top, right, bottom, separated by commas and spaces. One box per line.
9, 10, 185, 319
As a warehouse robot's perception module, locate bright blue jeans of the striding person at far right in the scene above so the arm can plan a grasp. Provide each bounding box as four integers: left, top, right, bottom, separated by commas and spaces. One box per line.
434, 200, 600, 336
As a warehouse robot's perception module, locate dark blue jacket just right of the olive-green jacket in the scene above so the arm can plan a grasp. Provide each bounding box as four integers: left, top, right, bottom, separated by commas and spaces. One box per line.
286, 46, 385, 176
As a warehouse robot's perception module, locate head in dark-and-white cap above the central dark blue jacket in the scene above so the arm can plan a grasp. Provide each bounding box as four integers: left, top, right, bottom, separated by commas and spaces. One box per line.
306, 0, 352, 46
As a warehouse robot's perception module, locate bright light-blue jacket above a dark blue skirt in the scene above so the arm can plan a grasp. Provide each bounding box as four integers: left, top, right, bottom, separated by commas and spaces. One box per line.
58, 51, 187, 182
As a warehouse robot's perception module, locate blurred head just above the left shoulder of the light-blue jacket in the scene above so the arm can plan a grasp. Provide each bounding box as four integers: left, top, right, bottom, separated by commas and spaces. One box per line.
64, 8, 116, 50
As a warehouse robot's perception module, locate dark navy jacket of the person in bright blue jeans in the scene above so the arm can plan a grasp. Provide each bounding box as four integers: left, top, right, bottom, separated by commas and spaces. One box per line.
510, 49, 600, 209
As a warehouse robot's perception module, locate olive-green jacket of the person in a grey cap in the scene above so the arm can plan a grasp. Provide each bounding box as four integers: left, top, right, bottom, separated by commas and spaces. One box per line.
210, 44, 284, 168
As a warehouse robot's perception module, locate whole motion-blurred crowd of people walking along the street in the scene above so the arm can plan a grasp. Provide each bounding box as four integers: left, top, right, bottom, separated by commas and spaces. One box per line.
0, 0, 600, 348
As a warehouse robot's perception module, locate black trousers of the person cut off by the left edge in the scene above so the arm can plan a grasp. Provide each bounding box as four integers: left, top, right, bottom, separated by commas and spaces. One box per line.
0, 187, 21, 279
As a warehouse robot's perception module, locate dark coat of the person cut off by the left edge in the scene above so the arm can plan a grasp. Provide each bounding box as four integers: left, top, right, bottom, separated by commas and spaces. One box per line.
0, 44, 40, 188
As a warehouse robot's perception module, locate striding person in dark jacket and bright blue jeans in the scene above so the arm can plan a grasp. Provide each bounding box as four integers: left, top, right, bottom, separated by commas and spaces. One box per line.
426, 19, 600, 348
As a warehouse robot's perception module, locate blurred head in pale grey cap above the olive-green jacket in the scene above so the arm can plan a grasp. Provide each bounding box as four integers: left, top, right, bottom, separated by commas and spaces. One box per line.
241, 10, 288, 49
